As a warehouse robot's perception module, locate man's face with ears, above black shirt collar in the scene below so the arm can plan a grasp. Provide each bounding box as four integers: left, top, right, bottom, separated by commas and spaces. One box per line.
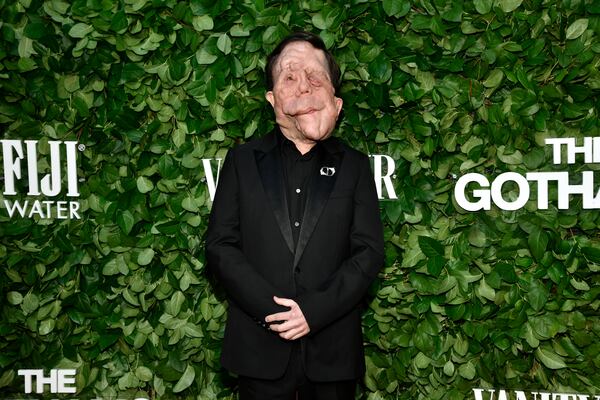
266, 42, 342, 146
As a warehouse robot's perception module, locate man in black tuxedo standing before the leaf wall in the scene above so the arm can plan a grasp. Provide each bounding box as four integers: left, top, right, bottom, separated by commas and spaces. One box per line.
206, 32, 383, 400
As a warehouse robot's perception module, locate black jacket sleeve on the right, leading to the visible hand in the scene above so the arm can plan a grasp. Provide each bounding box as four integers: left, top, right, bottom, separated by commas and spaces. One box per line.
296, 156, 384, 334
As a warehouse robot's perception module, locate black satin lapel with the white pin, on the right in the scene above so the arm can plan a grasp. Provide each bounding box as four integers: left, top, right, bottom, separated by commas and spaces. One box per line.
294, 151, 344, 268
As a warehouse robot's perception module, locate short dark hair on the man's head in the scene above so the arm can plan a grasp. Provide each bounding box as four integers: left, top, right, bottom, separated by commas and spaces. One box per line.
265, 31, 342, 96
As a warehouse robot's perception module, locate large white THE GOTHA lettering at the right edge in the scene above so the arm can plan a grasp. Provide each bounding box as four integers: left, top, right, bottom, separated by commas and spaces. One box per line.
454, 137, 600, 211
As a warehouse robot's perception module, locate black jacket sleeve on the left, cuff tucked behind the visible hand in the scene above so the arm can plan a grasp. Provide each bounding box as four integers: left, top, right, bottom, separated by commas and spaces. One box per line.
205, 149, 286, 327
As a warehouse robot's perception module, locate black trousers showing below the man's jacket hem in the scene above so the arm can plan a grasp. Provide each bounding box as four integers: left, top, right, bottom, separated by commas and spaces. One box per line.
239, 341, 356, 400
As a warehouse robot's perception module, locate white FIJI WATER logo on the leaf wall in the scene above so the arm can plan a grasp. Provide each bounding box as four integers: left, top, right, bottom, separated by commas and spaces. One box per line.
0, 139, 85, 219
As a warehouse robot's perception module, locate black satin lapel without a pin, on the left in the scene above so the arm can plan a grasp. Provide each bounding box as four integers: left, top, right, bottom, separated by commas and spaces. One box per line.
255, 146, 294, 253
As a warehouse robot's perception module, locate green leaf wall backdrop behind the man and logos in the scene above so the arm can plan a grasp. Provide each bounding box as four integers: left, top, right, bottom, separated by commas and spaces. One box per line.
0, 0, 600, 399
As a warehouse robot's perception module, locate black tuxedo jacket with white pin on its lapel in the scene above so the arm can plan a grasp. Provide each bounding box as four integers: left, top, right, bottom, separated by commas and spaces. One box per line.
206, 130, 383, 381
